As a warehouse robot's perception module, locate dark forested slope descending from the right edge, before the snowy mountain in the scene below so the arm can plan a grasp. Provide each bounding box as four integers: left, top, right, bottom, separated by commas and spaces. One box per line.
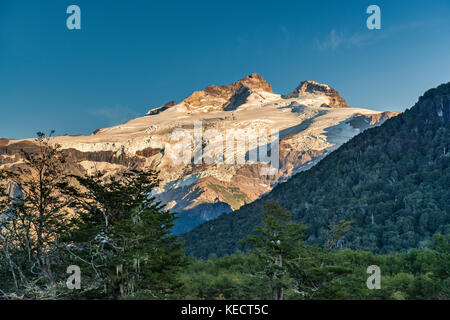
182, 83, 450, 258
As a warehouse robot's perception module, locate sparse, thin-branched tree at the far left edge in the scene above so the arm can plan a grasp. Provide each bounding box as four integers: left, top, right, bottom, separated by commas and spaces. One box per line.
0, 133, 72, 296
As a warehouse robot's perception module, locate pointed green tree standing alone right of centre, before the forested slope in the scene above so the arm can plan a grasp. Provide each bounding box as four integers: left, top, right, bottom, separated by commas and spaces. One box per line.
243, 202, 351, 300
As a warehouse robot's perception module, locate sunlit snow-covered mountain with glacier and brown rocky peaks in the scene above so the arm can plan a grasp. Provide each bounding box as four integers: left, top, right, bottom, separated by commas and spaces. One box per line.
0, 73, 398, 232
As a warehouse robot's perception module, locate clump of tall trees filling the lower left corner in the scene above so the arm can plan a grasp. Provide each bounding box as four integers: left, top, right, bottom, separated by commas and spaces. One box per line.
0, 133, 186, 299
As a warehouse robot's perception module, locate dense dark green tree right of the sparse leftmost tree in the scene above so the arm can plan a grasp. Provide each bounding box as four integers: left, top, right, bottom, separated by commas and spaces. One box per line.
66, 170, 186, 299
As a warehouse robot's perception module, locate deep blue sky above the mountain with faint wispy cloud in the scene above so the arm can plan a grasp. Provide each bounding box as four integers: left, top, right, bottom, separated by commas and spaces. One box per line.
0, 0, 450, 138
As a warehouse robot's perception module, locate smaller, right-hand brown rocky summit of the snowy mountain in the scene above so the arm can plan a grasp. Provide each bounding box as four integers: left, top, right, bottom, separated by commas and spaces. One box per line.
286, 81, 349, 108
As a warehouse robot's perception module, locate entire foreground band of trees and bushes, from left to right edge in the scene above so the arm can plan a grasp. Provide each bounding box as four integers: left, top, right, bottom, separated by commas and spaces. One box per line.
0, 135, 450, 300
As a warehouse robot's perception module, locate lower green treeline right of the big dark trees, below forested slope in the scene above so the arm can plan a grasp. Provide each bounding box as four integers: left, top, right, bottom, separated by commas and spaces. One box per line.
178, 202, 450, 300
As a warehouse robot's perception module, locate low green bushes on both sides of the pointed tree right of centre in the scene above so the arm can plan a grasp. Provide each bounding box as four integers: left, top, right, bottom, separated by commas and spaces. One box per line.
180, 237, 450, 300
